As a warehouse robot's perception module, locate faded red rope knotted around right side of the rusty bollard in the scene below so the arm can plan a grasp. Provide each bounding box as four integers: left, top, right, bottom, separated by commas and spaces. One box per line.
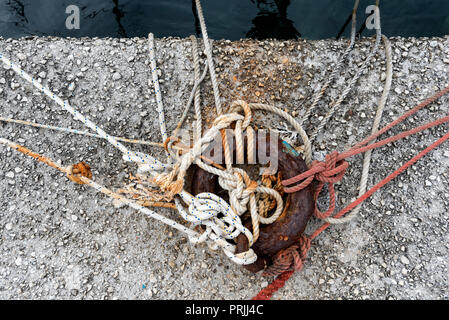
253, 86, 449, 300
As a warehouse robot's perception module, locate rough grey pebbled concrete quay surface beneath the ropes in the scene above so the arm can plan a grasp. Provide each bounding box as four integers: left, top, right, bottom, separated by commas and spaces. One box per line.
0, 37, 449, 299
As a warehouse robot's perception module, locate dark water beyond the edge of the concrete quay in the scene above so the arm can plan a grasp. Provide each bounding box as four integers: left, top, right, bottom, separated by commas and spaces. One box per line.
0, 0, 449, 40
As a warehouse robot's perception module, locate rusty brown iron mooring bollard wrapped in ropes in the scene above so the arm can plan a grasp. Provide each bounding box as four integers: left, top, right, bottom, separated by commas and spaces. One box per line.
192, 131, 314, 272
